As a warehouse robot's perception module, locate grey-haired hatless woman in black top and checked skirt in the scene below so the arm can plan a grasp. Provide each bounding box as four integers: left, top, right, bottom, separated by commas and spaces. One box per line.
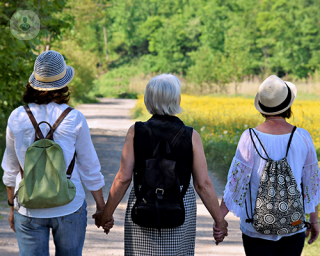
94, 74, 227, 256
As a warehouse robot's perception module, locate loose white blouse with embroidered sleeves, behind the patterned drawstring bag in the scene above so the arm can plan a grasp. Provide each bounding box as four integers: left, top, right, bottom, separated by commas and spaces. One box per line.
223, 128, 320, 241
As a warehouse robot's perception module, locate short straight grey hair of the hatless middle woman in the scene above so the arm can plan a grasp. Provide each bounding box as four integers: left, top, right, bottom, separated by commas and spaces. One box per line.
144, 74, 181, 116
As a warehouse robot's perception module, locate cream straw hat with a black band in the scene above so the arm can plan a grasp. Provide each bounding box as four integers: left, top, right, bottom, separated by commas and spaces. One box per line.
254, 75, 297, 116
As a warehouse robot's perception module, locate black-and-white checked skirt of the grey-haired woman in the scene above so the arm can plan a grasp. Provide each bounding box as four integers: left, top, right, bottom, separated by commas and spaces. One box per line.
124, 185, 197, 256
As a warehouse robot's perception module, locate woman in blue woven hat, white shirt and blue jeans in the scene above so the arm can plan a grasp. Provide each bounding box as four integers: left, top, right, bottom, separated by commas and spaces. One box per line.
1, 50, 109, 256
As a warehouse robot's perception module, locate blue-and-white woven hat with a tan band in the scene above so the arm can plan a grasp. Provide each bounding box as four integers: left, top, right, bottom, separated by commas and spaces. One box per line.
29, 50, 74, 91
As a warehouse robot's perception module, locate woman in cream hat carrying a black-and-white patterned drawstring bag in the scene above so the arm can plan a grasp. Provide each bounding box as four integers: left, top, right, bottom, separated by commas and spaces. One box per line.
214, 75, 320, 256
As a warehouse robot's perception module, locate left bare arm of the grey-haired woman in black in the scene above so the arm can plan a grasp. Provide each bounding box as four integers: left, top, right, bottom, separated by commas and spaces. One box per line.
95, 125, 134, 226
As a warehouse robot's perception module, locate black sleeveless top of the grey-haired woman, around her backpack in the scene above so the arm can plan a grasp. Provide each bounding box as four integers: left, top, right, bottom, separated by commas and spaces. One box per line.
133, 115, 193, 189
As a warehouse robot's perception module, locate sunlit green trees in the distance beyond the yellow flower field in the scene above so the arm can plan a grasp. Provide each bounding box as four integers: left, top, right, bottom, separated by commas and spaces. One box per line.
101, 0, 320, 91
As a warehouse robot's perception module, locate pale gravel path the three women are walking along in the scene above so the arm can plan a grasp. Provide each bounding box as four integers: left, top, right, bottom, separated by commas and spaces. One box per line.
0, 99, 244, 256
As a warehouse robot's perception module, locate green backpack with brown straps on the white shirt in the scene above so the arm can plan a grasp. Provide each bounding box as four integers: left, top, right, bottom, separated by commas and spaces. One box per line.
15, 106, 76, 209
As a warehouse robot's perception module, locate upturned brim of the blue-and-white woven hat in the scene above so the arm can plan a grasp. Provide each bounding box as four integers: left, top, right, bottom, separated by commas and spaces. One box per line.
29, 65, 75, 91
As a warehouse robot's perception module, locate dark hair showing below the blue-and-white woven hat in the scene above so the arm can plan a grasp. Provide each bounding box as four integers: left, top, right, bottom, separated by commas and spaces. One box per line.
22, 83, 70, 104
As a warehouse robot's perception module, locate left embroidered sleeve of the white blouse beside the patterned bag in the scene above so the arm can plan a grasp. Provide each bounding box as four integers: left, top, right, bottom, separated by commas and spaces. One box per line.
223, 130, 254, 217
